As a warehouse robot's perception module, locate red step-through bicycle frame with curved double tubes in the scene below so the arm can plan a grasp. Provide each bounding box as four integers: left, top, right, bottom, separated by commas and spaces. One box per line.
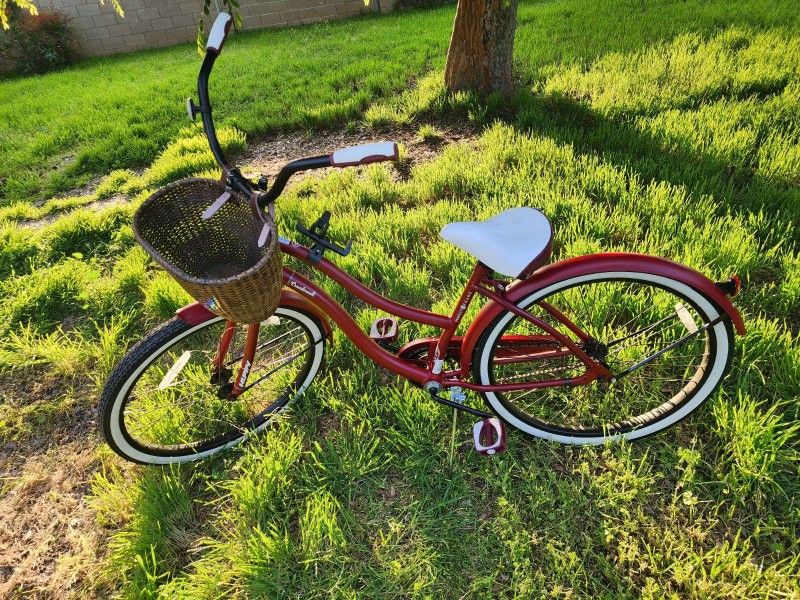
280, 238, 611, 392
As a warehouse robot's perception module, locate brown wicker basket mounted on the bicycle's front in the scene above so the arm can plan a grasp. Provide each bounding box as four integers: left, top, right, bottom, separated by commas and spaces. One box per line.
133, 179, 282, 323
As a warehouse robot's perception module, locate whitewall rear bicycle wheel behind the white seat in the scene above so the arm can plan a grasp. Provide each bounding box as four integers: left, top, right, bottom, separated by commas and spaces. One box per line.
472, 272, 733, 444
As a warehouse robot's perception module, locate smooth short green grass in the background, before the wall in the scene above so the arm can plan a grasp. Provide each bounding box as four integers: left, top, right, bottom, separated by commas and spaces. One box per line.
0, 0, 797, 204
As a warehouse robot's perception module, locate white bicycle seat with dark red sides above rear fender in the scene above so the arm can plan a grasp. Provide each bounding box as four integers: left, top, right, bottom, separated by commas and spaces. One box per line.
440, 207, 553, 278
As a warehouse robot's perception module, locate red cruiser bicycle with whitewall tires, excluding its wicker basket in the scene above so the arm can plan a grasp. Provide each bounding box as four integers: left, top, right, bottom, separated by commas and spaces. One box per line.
100, 13, 744, 464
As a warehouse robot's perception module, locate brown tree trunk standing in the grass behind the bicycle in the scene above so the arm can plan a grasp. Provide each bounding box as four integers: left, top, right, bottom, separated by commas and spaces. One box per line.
444, 0, 517, 95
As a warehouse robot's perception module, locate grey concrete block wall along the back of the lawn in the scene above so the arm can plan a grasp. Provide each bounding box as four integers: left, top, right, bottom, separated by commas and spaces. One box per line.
36, 0, 386, 56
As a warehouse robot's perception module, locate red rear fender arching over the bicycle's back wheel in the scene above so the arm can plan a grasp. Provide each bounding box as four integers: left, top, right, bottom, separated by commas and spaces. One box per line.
461, 252, 745, 376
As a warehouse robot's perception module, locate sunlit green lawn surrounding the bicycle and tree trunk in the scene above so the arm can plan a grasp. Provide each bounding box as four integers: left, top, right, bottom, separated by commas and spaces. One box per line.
0, 0, 800, 599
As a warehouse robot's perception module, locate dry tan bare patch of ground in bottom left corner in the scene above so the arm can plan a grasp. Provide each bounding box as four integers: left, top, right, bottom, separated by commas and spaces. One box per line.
0, 369, 102, 598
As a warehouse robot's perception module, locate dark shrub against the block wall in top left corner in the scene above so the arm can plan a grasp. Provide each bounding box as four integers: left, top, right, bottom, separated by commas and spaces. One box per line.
0, 9, 76, 75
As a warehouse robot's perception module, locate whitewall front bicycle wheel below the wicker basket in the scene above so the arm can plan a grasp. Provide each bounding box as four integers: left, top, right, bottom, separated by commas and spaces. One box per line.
100, 307, 325, 464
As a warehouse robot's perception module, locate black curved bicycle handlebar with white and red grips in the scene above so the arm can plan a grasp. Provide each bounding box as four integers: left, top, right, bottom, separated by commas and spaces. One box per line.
191, 12, 399, 208
